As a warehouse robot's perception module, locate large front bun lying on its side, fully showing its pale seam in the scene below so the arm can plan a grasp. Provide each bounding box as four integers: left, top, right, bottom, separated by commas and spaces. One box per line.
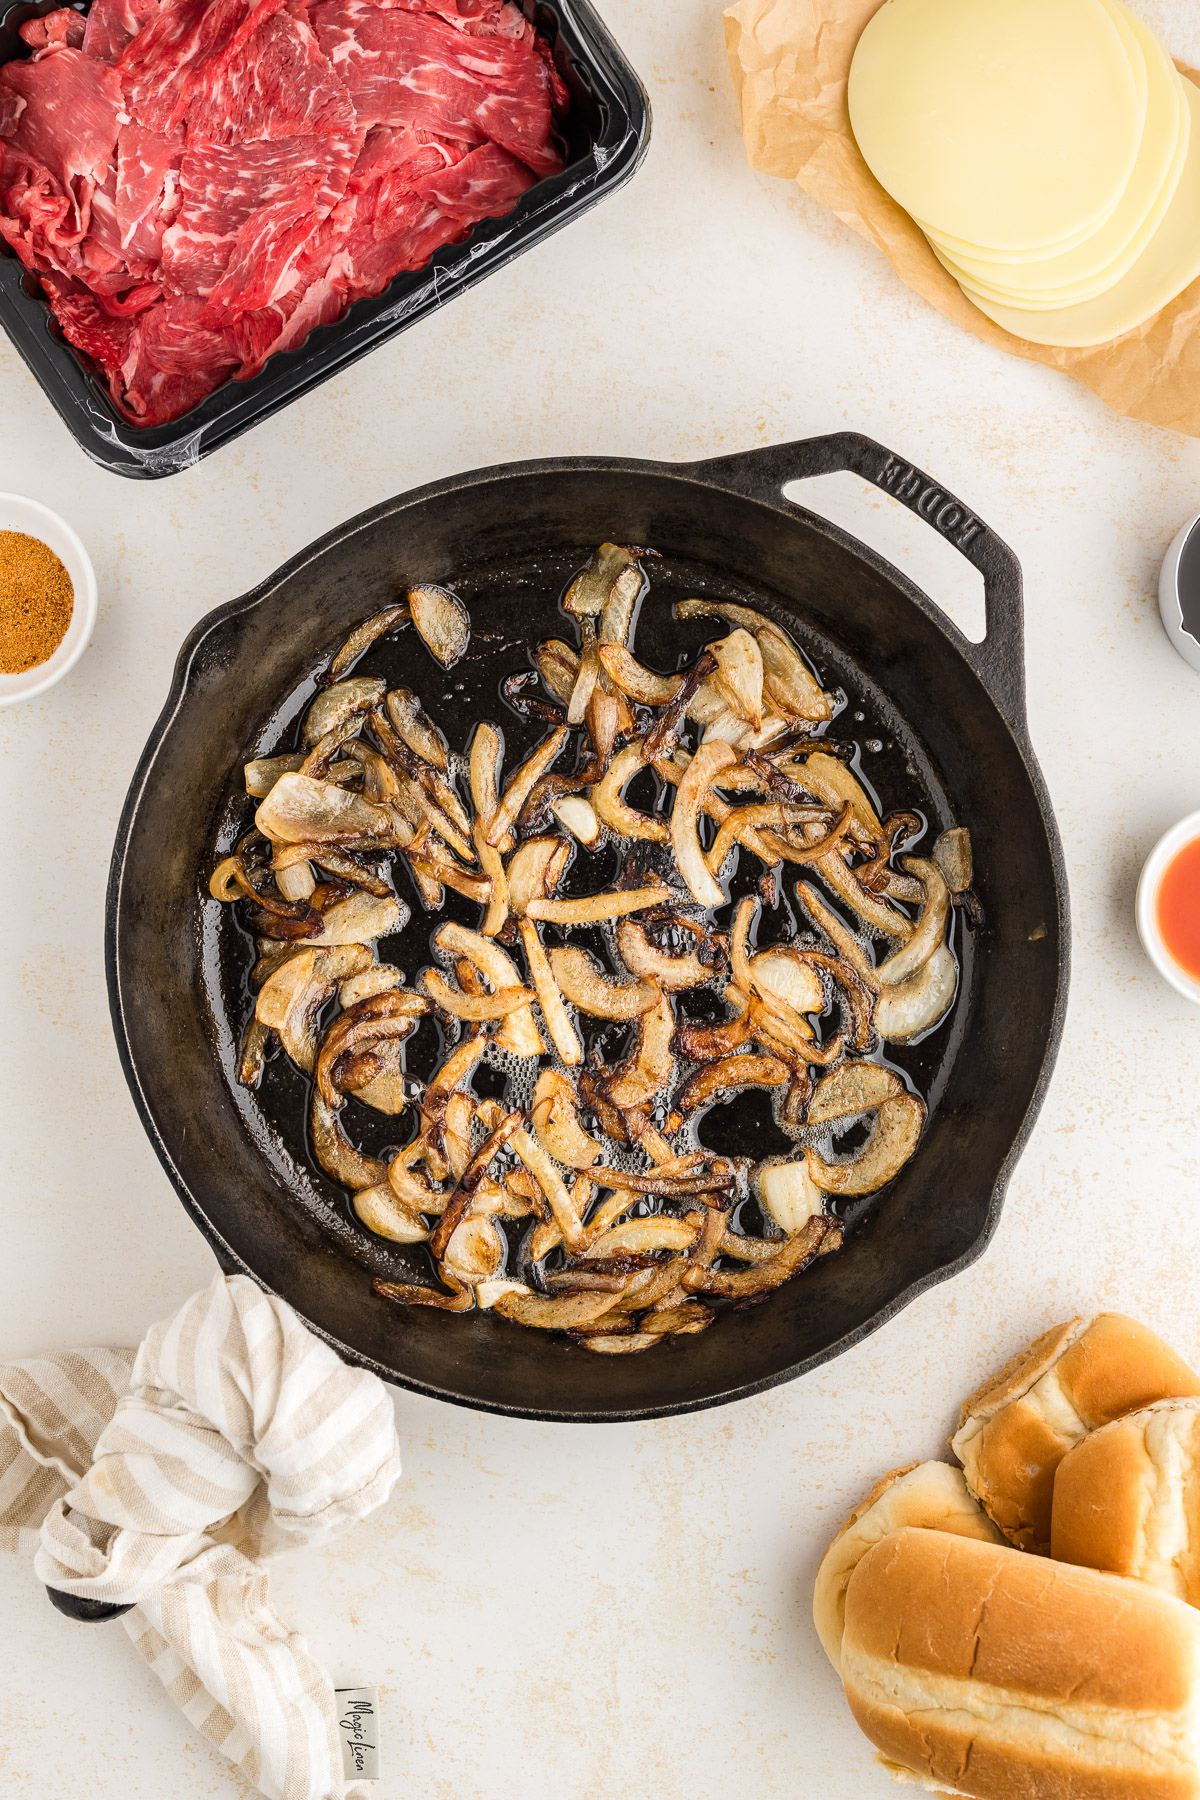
842, 1528, 1200, 1800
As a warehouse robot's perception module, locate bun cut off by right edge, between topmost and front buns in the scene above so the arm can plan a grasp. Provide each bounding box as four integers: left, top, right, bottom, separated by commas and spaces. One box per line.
1051, 1400, 1200, 1606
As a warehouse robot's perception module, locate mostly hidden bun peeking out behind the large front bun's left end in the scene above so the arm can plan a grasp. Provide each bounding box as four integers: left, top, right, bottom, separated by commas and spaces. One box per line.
813, 1462, 1002, 1669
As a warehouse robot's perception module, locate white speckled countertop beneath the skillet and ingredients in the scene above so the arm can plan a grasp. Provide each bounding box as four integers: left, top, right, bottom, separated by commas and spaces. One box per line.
0, 0, 1200, 1800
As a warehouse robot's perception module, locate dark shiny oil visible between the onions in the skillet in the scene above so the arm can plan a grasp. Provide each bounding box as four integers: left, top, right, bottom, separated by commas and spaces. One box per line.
211, 549, 970, 1280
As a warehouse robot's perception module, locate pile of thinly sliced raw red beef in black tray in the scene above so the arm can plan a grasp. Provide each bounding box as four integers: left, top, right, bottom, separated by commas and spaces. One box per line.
0, 0, 567, 425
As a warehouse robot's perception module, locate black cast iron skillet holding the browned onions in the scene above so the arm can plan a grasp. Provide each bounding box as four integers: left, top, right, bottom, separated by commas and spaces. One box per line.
106, 434, 1069, 1420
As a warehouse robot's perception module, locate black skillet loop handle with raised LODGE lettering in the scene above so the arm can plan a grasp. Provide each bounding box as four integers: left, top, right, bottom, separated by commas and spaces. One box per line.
698, 432, 1025, 731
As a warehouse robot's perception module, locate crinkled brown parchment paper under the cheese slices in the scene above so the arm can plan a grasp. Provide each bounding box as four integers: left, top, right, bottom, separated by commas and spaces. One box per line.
725, 0, 1200, 437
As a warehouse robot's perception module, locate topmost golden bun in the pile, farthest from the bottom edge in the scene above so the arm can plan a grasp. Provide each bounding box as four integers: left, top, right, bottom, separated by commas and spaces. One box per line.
950, 1312, 1200, 1553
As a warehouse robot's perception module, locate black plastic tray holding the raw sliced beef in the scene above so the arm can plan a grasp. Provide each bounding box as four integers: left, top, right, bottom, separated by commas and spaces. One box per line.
0, 0, 649, 481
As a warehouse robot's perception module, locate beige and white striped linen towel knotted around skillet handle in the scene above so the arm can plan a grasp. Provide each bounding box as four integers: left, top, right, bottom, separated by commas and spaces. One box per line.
0, 1276, 399, 1800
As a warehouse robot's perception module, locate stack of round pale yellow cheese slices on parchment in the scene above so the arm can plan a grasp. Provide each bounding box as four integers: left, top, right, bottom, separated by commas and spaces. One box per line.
849, 0, 1200, 346
